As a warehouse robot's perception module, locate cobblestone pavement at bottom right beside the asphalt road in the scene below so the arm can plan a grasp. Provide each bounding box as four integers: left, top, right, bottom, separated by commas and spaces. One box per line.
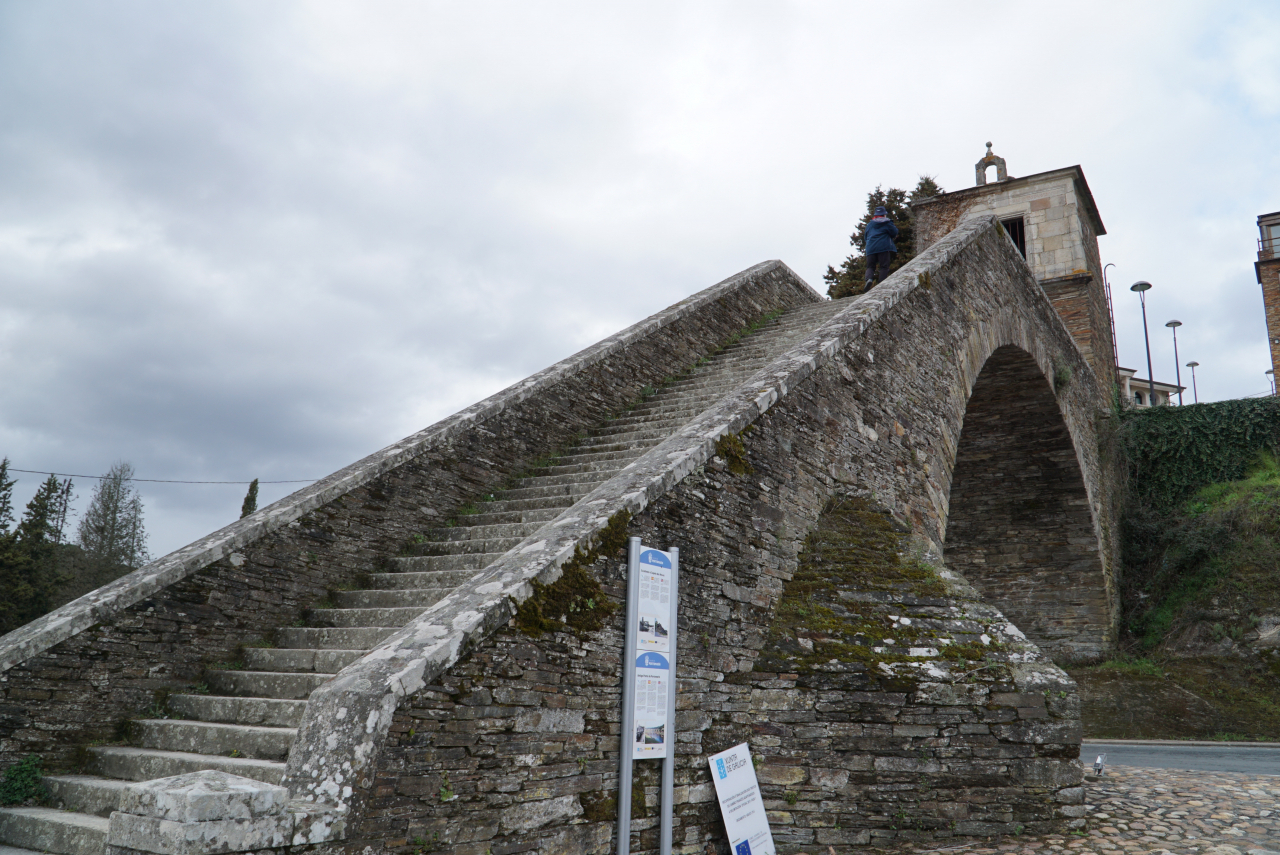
896, 765, 1280, 855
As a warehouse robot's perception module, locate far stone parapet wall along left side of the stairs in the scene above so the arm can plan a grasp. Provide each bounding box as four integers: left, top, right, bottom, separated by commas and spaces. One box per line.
0, 262, 818, 769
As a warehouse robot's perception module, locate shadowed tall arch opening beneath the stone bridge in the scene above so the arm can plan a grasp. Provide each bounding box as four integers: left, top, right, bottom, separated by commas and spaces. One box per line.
943, 346, 1111, 664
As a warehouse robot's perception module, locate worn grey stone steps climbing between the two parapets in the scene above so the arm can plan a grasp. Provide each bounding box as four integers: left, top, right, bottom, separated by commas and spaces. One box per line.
0, 296, 845, 855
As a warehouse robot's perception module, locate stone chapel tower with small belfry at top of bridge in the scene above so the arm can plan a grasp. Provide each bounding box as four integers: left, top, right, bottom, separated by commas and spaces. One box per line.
911, 142, 1121, 385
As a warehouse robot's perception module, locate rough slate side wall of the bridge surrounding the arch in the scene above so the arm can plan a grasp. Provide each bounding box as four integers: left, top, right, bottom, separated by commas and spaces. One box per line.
333, 224, 1111, 855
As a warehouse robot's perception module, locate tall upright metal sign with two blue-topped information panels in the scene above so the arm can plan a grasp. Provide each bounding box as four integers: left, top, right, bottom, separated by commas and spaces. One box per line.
617, 538, 680, 855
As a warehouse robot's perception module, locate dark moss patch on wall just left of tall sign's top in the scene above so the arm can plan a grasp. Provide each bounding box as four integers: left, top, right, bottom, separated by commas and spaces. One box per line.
516, 511, 631, 637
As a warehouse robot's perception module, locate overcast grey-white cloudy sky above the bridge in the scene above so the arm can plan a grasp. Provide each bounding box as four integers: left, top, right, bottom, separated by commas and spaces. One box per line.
0, 0, 1280, 555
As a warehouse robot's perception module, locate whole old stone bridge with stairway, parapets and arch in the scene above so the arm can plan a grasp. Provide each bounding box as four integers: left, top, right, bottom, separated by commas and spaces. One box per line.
0, 208, 1116, 855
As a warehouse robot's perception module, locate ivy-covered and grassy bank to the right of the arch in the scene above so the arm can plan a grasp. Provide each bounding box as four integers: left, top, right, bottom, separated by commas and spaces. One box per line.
1073, 398, 1280, 740
